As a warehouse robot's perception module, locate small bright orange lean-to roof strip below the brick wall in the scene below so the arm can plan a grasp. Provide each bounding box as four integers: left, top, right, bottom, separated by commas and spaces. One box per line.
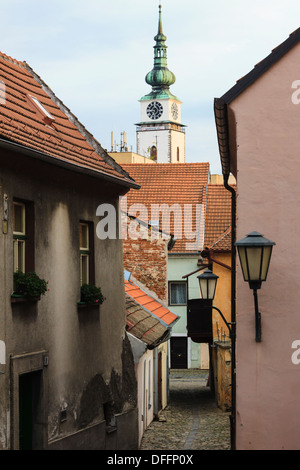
125, 279, 179, 332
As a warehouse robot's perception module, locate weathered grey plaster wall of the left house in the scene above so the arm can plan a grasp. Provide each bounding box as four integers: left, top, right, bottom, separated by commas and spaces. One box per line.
0, 150, 136, 448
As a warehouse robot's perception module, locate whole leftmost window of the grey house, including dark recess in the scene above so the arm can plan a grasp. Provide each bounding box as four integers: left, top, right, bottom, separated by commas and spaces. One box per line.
13, 200, 34, 273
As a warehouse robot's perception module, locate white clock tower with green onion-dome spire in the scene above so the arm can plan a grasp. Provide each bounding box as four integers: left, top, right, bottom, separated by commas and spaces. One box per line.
136, 5, 185, 163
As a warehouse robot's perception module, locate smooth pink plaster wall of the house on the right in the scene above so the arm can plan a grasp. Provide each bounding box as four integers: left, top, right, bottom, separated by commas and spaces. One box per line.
229, 44, 300, 450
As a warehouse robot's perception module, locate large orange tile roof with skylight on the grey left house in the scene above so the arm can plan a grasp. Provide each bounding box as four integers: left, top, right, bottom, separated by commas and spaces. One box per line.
0, 52, 136, 183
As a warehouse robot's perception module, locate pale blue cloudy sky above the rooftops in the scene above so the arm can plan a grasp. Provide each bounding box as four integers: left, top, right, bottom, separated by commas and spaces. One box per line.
0, 0, 300, 174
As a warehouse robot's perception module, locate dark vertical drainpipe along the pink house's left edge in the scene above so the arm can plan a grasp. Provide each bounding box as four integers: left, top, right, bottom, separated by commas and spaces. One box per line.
224, 174, 236, 450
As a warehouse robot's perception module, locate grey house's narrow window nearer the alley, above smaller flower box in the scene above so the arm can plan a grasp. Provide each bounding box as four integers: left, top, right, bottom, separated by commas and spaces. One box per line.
79, 222, 95, 286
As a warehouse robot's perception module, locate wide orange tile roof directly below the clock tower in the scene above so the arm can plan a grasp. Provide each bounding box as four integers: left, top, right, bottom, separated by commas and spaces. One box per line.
122, 163, 209, 253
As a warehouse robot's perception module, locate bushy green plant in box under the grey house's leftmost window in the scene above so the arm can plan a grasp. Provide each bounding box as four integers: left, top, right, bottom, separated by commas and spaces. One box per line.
14, 271, 48, 297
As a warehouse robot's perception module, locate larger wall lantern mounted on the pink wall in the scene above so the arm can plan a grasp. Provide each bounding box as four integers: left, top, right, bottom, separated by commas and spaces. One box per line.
235, 232, 276, 343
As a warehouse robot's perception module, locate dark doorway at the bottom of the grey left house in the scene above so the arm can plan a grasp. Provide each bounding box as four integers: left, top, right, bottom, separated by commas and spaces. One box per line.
19, 371, 43, 450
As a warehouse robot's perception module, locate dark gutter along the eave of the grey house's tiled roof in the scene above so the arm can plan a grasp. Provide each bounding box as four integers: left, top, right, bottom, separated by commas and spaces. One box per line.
0, 139, 140, 189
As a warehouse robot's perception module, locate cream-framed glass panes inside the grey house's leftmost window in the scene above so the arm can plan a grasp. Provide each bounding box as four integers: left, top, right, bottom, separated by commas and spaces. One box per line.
13, 202, 27, 273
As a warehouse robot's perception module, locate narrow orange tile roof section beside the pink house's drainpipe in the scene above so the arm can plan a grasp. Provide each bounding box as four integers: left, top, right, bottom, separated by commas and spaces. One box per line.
204, 184, 235, 251
